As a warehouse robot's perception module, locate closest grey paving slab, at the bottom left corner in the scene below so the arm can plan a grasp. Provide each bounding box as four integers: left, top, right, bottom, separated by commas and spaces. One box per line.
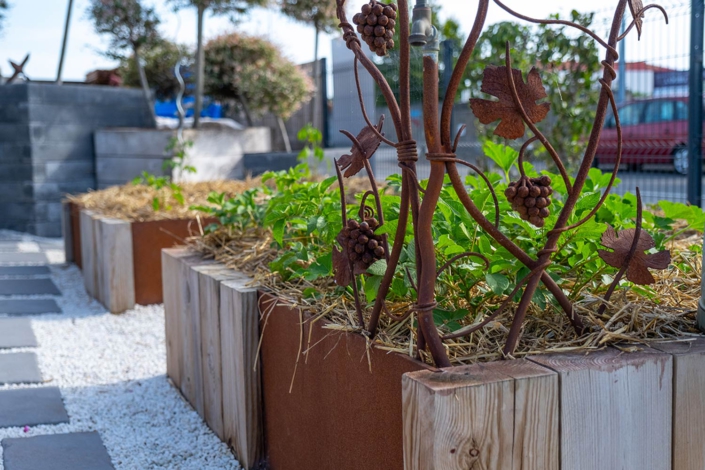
2, 432, 115, 470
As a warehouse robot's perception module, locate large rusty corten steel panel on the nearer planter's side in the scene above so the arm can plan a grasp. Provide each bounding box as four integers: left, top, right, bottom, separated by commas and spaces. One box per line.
260, 294, 429, 470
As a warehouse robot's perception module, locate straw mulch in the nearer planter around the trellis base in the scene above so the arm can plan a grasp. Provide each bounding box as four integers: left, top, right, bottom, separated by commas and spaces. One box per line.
191, 224, 702, 365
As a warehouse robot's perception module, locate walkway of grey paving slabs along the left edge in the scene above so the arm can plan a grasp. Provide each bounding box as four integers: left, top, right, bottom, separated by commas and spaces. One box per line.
0, 238, 114, 470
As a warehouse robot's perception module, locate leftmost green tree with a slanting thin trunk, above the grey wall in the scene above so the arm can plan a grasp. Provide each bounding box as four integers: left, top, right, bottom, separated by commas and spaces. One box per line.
88, 0, 160, 123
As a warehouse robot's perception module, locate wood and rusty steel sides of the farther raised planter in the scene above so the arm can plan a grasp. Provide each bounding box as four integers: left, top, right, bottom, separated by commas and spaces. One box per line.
63, 203, 215, 313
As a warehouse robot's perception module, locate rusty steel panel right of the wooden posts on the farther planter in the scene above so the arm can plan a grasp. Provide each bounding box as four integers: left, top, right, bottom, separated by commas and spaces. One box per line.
132, 219, 217, 305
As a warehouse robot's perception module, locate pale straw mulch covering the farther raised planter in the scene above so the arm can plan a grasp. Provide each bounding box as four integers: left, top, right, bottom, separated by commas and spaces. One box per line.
66, 178, 262, 222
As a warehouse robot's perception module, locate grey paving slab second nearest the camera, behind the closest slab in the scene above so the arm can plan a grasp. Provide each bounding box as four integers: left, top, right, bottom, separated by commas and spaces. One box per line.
0, 387, 69, 428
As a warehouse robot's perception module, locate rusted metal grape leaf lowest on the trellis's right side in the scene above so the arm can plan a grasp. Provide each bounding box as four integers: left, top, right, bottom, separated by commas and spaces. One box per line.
597, 226, 671, 285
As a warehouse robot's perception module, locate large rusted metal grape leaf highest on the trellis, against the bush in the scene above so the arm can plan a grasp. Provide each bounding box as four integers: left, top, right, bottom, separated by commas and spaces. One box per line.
470, 65, 551, 139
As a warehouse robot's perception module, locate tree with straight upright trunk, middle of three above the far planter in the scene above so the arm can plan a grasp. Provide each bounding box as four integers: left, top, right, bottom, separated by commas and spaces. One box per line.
168, 0, 268, 128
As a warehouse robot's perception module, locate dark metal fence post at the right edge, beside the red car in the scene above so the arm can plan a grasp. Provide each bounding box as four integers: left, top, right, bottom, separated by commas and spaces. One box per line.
688, 0, 705, 207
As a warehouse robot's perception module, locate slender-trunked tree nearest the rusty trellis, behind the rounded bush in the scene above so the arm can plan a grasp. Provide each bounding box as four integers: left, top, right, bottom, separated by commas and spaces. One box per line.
280, 0, 338, 127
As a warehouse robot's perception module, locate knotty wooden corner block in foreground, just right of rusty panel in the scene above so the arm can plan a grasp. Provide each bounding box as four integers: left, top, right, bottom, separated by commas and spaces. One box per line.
402, 365, 514, 470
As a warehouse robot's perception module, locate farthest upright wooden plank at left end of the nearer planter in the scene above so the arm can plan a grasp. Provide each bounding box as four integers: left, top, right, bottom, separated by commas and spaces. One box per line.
162, 248, 201, 389
